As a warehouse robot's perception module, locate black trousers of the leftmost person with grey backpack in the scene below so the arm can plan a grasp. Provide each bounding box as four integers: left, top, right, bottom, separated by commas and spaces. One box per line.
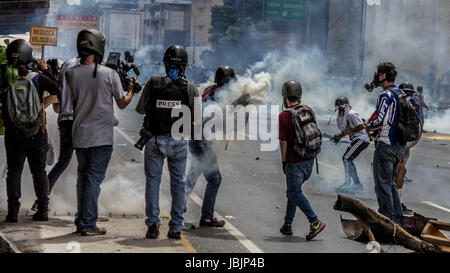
5, 127, 48, 214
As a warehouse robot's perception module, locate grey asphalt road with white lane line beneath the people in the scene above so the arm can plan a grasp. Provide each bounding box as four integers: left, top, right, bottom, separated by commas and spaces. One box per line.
0, 98, 450, 253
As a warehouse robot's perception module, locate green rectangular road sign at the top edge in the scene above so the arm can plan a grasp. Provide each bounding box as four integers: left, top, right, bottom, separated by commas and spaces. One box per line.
264, 0, 306, 21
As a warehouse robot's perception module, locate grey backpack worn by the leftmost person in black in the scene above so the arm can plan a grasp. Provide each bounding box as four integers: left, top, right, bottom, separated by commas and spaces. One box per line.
6, 73, 44, 138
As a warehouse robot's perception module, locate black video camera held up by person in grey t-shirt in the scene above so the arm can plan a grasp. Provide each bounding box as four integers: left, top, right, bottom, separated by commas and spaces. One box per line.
105, 50, 142, 94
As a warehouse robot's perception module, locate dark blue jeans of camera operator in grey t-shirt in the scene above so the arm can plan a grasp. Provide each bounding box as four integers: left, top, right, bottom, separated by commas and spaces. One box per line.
75, 146, 113, 230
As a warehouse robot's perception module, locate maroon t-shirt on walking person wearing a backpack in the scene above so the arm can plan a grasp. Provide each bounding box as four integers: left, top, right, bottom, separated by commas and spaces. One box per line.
278, 105, 314, 164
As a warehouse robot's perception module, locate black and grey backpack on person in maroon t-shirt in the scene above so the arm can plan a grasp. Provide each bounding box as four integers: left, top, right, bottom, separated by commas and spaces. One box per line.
286, 106, 322, 159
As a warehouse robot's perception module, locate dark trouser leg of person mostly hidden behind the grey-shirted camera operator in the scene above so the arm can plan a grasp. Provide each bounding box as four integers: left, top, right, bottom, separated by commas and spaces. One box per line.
48, 120, 74, 195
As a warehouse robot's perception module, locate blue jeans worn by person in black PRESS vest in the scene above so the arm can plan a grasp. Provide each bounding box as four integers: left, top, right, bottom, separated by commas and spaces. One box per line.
144, 135, 187, 232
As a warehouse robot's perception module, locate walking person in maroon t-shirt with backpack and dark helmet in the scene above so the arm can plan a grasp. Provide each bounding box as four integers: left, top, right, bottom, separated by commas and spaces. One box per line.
279, 81, 325, 240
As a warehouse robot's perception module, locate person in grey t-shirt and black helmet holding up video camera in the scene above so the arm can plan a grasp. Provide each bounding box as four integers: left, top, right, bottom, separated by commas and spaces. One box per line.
65, 29, 133, 236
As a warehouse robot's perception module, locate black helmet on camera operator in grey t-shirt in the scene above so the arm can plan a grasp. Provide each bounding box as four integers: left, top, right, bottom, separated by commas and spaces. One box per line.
77, 29, 106, 61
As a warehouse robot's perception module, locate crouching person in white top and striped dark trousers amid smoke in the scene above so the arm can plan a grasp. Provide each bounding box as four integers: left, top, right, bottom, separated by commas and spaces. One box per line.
331, 97, 370, 192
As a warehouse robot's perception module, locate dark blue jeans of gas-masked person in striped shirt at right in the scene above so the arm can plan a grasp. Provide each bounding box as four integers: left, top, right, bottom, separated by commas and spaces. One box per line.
373, 141, 405, 220
